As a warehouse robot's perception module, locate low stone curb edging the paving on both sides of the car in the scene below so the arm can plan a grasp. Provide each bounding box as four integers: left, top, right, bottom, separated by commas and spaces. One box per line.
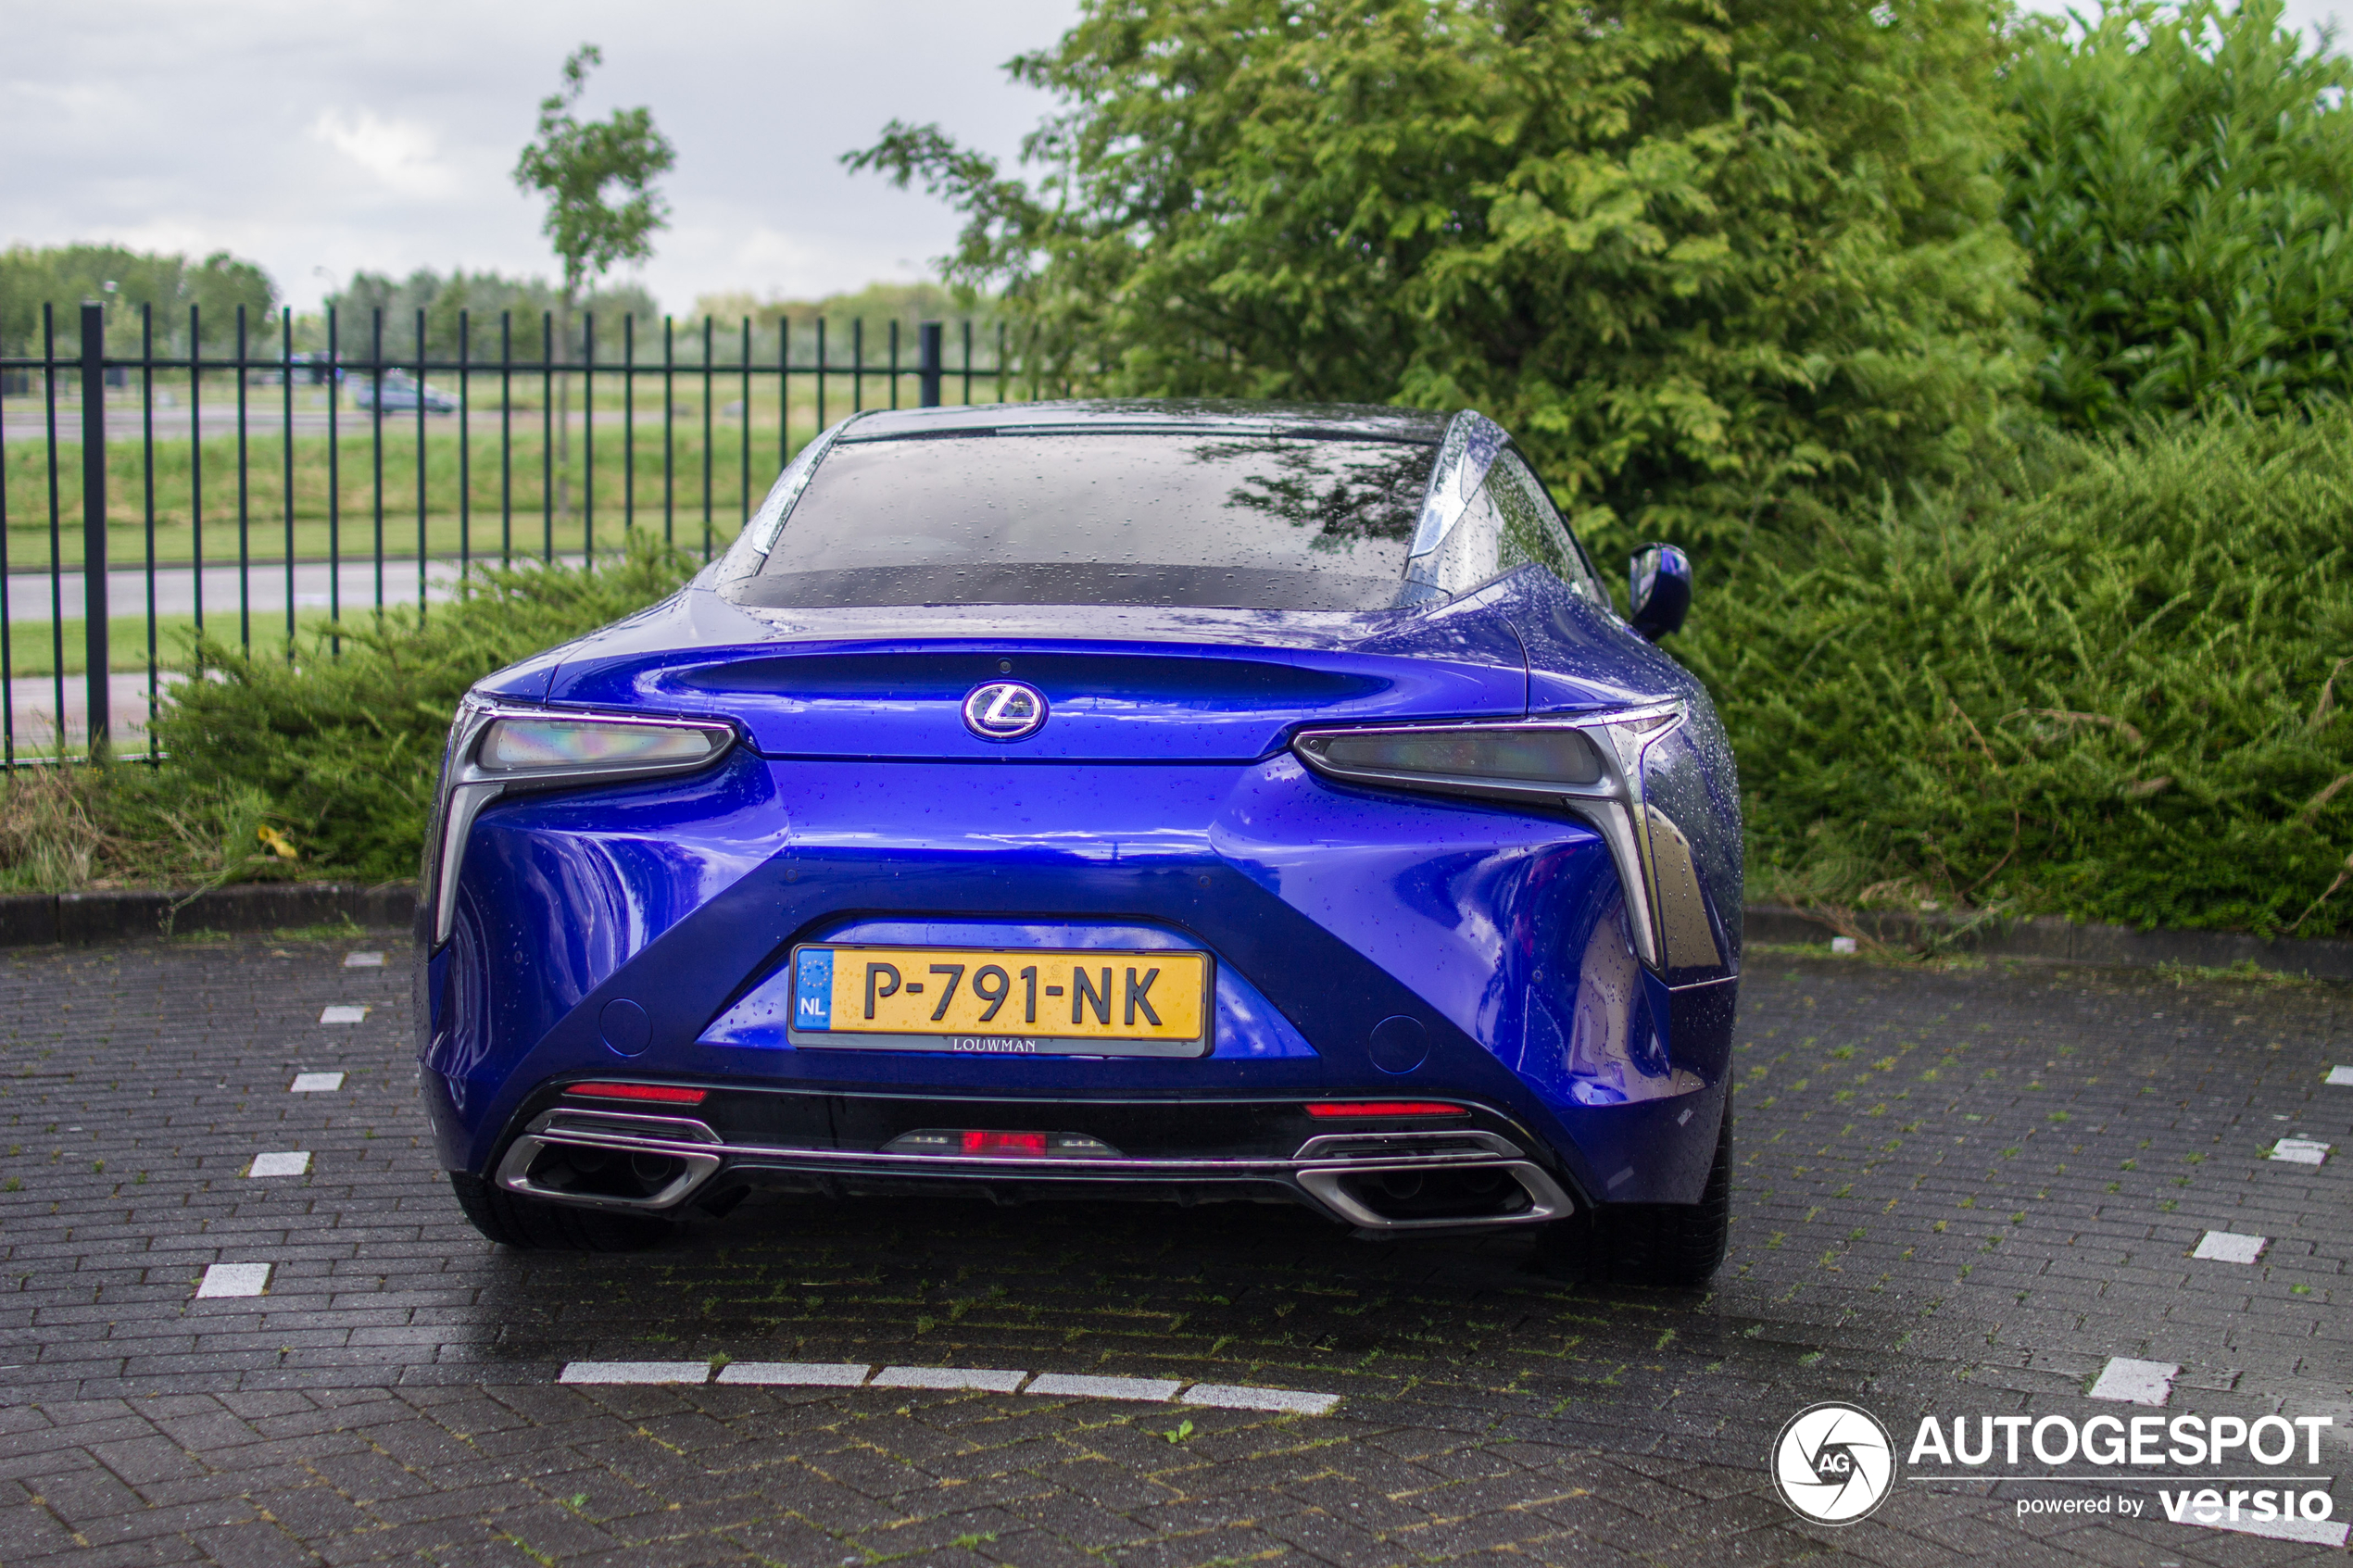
0, 882, 2353, 980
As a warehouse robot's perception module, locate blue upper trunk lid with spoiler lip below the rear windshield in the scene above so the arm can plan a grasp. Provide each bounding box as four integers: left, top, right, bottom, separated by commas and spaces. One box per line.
515, 569, 1680, 761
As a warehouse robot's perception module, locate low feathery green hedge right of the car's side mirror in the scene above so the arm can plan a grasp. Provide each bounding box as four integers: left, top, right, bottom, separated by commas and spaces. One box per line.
1675, 409, 2353, 935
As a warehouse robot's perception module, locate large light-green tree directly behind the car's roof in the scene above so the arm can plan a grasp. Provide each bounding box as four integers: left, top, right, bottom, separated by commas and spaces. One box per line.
849, 0, 2026, 561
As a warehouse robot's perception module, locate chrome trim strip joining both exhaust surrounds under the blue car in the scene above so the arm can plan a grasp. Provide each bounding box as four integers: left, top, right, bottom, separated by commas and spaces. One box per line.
497, 1108, 1577, 1235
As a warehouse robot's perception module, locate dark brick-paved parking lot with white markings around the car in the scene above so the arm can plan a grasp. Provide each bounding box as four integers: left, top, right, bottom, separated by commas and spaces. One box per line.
0, 935, 2353, 1568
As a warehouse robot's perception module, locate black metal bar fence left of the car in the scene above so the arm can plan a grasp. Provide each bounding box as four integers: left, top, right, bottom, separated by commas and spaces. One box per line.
0, 303, 1016, 769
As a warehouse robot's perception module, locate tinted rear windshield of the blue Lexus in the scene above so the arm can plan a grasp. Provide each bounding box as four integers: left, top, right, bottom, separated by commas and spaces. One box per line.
734, 433, 1438, 608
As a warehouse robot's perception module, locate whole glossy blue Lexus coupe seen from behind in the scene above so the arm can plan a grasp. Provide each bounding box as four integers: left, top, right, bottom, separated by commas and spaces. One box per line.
417, 402, 1742, 1284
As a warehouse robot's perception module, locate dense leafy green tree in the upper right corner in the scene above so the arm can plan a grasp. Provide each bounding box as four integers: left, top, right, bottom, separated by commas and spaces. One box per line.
2005, 0, 2353, 428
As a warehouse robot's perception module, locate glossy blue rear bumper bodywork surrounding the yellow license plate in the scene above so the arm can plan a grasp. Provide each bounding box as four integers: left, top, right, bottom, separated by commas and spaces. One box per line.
419, 755, 1737, 1213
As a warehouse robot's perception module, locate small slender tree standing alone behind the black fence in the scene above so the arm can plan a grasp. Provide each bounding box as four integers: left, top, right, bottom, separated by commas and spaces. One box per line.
515, 44, 678, 526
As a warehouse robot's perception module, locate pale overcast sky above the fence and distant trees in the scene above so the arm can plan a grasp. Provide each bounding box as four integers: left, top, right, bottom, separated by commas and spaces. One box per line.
0, 0, 2353, 310
